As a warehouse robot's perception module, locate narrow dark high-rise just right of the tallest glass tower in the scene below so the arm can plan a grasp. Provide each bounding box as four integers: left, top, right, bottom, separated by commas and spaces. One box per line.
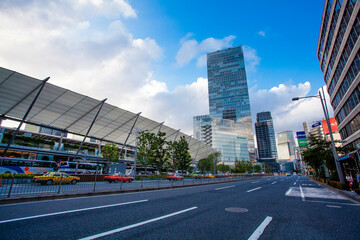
255, 112, 277, 161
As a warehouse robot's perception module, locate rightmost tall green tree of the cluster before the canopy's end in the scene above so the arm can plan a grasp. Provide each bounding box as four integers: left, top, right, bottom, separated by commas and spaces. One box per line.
168, 136, 191, 171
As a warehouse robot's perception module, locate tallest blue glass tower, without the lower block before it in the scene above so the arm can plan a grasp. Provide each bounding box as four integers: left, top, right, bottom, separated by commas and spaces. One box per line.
207, 46, 255, 158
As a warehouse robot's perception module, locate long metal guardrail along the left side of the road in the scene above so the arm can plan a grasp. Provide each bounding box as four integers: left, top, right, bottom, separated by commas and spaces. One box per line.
0, 174, 268, 200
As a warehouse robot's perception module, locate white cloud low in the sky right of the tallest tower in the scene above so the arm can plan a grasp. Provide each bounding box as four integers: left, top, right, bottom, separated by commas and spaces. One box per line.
250, 82, 332, 135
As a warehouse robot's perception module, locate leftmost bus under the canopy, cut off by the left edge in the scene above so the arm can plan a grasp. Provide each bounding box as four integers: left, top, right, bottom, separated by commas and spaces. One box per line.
0, 157, 58, 174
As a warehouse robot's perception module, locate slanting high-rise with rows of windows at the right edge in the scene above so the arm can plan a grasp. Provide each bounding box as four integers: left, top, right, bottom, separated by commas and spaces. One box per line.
317, 0, 360, 147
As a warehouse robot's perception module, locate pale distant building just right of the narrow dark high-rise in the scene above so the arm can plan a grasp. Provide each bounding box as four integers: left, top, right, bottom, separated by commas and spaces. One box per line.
276, 131, 296, 161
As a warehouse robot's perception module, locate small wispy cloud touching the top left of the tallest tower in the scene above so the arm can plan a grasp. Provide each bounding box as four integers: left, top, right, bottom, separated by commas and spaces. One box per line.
175, 34, 235, 67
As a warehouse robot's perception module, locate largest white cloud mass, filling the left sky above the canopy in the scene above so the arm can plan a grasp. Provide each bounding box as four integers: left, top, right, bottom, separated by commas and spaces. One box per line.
0, 0, 208, 134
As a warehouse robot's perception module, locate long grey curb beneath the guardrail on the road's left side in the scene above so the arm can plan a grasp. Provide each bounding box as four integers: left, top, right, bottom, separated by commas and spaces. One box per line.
0, 177, 263, 205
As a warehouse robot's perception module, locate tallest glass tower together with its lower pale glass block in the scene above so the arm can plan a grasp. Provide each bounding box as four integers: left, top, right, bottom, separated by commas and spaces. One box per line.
194, 46, 256, 165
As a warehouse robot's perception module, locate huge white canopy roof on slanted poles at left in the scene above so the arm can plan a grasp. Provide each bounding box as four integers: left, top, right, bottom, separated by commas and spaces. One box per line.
0, 67, 215, 160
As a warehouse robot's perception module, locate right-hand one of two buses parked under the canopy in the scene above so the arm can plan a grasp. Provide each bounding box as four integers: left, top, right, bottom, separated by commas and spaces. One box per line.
59, 161, 104, 174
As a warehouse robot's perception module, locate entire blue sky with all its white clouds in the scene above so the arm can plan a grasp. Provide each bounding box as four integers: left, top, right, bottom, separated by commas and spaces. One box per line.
0, 0, 330, 138
